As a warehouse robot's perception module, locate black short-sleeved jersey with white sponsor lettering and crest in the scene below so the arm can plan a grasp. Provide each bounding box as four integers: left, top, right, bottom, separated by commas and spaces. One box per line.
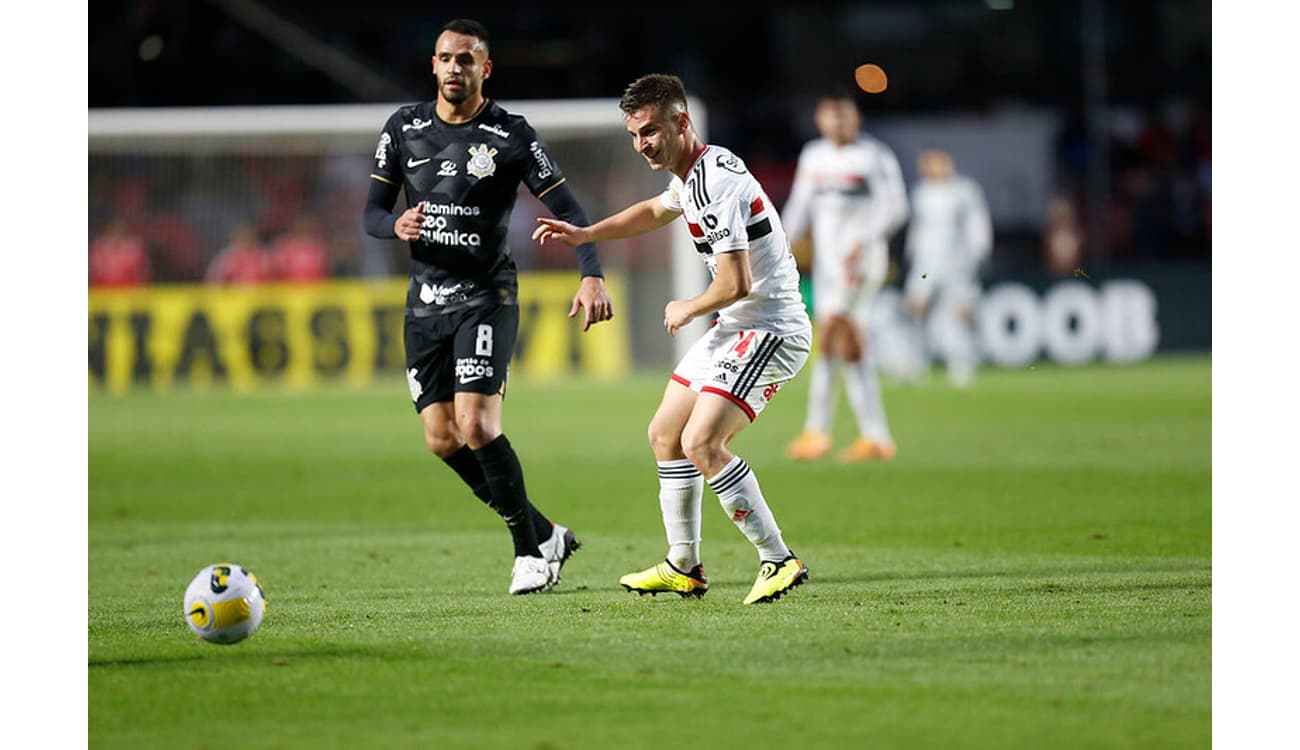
371, 100, 564, 309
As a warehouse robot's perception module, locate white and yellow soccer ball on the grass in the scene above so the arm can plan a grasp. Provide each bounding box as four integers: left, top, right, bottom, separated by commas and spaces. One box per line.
185, 563, 267, 643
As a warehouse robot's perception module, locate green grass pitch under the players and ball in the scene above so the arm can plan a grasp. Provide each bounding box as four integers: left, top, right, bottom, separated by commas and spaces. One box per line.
87, 356, 1212, 750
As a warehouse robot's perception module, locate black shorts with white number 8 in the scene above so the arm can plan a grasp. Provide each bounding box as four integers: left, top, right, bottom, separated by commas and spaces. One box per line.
404, 304, 519, 413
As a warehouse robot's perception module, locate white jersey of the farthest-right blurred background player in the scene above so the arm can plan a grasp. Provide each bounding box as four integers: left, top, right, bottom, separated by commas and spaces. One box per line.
906, 174, 993, 283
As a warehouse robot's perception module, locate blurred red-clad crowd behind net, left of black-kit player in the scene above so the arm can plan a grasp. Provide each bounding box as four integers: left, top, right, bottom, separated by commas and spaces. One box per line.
88, 156, 379, 287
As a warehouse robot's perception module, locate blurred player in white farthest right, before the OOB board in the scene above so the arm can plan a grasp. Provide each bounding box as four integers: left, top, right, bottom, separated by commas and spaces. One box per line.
904, 147, 993, 387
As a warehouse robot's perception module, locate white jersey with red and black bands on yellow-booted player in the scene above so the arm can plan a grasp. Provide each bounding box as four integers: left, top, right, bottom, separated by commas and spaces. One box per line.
660, 146, 811, 335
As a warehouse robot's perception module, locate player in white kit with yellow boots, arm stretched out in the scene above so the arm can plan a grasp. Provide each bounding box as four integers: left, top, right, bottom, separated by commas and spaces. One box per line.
533, 74, 813, 604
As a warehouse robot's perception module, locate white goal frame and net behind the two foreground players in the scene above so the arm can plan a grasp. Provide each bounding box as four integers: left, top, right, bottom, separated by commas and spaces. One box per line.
88, 99, 707, 379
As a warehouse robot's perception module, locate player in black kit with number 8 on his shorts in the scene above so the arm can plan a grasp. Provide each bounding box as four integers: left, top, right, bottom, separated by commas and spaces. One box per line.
365, 19, 614, 594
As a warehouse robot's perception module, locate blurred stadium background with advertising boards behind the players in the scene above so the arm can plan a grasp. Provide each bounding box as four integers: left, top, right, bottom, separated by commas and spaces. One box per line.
88, 0, 1210, 391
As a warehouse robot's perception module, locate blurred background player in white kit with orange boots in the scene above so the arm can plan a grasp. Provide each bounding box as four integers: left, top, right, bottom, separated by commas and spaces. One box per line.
781, 95, 907, 463
